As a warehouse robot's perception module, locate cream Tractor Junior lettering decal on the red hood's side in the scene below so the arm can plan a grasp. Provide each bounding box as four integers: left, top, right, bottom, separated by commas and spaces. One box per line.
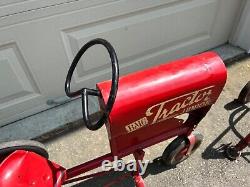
125, 86, 214, 133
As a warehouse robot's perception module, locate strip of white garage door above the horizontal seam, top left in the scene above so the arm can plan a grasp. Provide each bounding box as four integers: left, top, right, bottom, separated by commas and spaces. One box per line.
0, 0, 117, 27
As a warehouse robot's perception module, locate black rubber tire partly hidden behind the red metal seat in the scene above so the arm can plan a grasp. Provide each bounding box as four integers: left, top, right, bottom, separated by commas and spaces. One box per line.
0, 140, 49, 159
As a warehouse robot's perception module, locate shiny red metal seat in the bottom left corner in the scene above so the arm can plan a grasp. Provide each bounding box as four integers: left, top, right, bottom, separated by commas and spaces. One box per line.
0, 150, 64, 187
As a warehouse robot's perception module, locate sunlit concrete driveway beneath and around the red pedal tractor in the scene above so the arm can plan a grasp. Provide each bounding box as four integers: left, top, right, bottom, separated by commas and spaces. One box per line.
46, 59, 250, 187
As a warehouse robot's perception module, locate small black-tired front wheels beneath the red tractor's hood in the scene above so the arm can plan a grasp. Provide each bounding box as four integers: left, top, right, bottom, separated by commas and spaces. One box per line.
162, 132, 203, 166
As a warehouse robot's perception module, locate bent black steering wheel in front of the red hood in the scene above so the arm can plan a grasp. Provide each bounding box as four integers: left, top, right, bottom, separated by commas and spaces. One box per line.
65, 38, 119, 130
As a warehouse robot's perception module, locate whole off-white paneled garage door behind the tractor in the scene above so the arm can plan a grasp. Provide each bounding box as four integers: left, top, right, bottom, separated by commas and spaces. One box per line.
0, 0, 241, 126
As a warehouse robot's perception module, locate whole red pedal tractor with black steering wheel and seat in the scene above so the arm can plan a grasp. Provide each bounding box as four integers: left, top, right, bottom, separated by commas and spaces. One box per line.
0, 39, 227, 187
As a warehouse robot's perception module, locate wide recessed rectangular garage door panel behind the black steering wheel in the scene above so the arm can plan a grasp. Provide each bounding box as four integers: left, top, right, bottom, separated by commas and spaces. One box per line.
63, 0, 218, 87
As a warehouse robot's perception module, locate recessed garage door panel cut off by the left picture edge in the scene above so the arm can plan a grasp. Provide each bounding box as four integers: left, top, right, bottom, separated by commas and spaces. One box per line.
0, 43, 44, 126
